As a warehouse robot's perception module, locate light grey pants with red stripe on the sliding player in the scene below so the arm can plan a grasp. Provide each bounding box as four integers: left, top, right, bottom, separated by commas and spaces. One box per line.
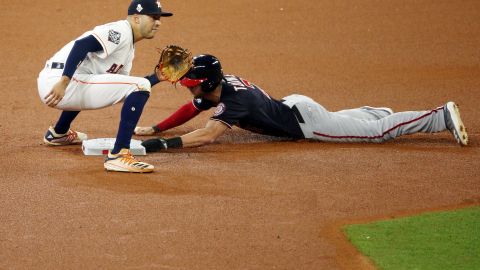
283, 95, 446, 142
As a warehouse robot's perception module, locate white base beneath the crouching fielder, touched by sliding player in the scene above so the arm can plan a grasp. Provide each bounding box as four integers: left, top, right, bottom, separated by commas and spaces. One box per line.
82, 138, 147, 156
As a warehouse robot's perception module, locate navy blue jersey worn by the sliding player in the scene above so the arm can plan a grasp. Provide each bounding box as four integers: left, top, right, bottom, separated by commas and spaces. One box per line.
193, 75, 304, 139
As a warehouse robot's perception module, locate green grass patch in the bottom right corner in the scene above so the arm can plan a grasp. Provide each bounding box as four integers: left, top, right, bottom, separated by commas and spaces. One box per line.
342, 206, 480, 270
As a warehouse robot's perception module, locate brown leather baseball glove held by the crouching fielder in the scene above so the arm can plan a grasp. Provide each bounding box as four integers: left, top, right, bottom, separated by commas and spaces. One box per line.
155, 45, 192, 83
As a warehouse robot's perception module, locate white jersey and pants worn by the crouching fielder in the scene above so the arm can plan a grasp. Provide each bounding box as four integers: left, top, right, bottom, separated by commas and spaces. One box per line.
37, 20, 151, 110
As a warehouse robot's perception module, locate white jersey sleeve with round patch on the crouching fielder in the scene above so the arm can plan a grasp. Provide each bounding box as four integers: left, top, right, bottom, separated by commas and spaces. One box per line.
91, 23, 128, 59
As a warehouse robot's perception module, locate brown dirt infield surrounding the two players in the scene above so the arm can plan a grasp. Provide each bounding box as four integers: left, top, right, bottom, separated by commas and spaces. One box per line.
0, 0, 480, 269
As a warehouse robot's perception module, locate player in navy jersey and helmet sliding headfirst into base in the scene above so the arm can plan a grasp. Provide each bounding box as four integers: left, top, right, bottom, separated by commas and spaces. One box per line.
135, 55, 468, 152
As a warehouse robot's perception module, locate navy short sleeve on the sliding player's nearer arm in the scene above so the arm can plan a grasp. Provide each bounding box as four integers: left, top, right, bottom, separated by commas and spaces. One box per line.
211, 98, 250, 128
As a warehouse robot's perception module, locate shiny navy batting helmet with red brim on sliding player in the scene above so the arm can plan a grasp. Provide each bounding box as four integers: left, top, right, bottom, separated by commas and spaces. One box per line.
180, 54, 223, 93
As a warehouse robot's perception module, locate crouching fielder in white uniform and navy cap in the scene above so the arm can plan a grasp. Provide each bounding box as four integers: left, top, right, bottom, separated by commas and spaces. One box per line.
38, 0, 176, 172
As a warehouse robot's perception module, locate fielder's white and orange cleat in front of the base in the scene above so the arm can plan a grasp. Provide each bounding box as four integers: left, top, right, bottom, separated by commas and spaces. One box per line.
103, 148, 154, 173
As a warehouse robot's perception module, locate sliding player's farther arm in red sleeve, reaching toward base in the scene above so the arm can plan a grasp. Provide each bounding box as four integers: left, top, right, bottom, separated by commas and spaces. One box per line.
135, 102, 200, 136
